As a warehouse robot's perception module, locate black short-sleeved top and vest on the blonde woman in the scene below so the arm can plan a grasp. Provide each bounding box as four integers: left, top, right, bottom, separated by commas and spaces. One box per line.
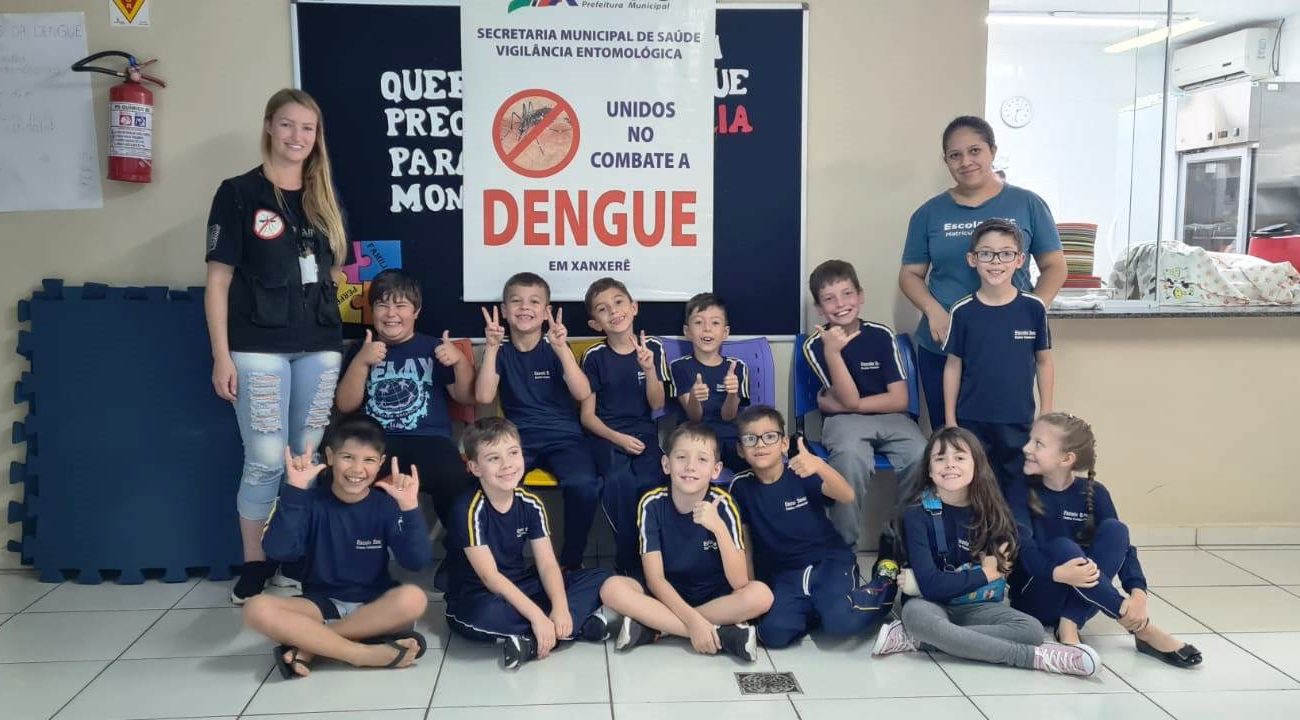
205, 166, 354, 352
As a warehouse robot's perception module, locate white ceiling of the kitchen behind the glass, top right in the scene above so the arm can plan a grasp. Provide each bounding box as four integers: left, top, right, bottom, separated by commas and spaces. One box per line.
988, 0, 1300, 45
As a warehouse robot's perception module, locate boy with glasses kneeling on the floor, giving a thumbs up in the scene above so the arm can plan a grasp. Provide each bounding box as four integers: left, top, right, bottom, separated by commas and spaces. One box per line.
731, 405, 894, 647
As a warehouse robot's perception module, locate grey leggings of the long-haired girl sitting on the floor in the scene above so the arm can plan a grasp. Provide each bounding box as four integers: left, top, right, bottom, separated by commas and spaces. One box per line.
902, 598, 1045, 669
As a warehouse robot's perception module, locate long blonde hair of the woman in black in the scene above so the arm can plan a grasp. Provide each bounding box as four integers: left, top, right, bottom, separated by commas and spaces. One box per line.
261, 87, 347, 266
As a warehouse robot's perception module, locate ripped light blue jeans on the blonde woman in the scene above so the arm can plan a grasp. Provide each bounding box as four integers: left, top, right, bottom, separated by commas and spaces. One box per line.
230, 352, 343, 520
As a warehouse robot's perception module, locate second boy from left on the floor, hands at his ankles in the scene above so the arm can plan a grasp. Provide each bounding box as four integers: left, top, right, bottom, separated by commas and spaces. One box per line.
446, 417, 610, 669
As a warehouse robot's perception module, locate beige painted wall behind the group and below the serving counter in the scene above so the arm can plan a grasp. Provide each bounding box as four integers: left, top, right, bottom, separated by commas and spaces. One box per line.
0, 0, 1300, 567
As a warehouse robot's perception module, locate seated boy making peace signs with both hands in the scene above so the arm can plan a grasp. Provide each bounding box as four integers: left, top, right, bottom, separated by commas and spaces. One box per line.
475, 273, 601, 569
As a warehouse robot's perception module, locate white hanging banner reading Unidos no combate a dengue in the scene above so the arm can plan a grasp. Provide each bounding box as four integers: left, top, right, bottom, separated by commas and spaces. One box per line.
460, 0, 716, 302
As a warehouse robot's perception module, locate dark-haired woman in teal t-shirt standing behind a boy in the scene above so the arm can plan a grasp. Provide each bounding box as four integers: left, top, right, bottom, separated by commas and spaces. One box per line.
898, 116, 1066, 426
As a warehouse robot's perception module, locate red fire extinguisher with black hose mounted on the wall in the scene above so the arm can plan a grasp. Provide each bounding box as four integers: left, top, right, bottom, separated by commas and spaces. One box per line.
73, 49, 166, 182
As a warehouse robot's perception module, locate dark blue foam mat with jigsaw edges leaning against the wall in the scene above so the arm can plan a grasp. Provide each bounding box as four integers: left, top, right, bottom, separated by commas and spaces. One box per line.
8, 281, 242, 584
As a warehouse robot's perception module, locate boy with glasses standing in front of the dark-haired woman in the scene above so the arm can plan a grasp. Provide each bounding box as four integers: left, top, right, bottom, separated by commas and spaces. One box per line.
944, 220, 1056, 495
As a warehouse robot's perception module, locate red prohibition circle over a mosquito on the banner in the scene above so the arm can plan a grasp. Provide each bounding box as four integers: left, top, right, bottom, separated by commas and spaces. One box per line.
491, 88, 580, 178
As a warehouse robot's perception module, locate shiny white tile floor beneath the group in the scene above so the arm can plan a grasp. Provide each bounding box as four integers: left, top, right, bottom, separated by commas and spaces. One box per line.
0, 547, 1300, 720
